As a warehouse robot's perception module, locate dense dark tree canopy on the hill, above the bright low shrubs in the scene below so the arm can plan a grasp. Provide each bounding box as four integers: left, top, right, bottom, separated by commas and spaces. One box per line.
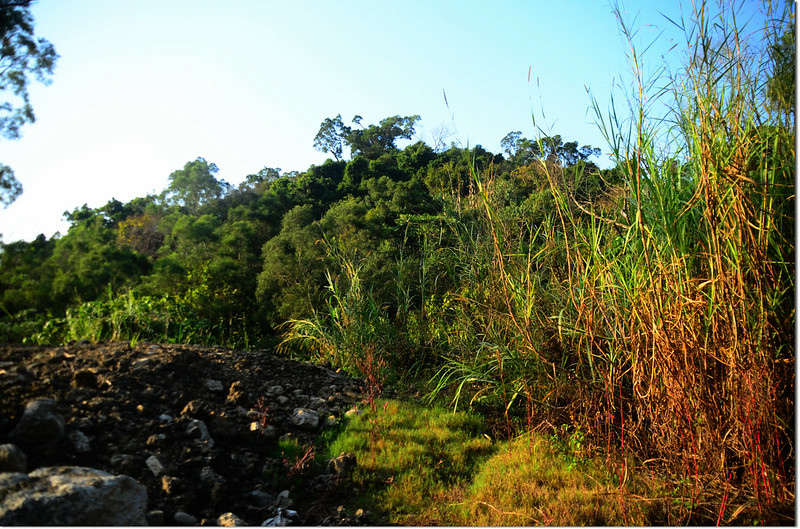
0, 116, 608, 344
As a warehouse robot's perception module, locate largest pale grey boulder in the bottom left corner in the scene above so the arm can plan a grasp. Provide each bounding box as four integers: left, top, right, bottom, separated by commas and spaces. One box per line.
0, 467, 147, 525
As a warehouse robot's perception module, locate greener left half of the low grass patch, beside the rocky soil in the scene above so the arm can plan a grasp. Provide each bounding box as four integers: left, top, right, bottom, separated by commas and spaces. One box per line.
329, 400, 496, 525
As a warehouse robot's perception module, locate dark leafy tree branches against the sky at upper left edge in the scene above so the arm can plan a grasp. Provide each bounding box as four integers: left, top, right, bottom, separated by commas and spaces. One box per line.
0, 0, 58, 206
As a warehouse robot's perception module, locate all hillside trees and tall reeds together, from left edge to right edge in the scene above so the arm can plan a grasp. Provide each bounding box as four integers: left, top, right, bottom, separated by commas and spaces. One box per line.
0, 3, 796, 523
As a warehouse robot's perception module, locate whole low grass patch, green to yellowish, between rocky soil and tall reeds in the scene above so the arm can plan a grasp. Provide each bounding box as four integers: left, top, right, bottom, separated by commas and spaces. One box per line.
328, 400, 663, 526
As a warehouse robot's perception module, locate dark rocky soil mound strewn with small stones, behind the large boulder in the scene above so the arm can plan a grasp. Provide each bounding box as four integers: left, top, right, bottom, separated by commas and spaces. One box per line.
0, 342, 380, 525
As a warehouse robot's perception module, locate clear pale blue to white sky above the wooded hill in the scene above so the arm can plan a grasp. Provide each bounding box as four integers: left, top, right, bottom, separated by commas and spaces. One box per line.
0, 0, 768, 243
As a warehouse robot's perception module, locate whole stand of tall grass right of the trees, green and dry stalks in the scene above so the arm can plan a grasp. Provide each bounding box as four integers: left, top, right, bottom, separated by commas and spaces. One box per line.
424, 1, 795, 523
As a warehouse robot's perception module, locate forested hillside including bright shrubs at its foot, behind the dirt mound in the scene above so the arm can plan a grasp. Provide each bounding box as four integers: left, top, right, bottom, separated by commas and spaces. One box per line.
0, 117, 608, 346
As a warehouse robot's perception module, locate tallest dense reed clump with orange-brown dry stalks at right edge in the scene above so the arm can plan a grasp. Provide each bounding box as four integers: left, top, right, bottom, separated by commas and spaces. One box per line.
548, 2, 795, 519
